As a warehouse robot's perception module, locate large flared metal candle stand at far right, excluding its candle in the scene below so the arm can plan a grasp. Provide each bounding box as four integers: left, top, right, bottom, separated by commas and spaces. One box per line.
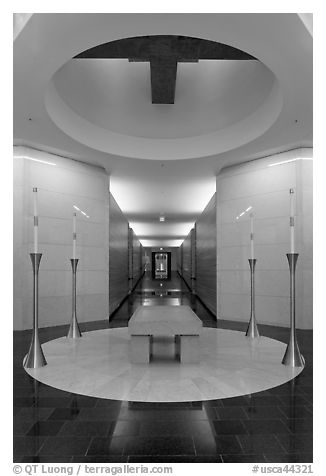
282, 253, 304, 367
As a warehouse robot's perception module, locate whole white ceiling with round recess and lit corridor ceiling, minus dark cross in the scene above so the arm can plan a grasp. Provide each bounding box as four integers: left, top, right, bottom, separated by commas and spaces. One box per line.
14, 13, 312, 246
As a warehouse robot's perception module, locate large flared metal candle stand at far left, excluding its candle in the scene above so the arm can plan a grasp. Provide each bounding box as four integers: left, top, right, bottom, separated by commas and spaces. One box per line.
24, 253, 47, 369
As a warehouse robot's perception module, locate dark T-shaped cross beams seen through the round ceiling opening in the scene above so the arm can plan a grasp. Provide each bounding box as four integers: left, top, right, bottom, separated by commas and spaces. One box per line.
75, 35, 256, 104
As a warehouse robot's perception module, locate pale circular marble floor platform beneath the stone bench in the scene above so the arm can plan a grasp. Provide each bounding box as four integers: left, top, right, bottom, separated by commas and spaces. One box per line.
25, 327, 303, 402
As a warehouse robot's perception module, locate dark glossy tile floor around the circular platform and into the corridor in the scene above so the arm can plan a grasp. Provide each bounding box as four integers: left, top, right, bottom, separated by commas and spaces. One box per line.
13, 275, 313, 463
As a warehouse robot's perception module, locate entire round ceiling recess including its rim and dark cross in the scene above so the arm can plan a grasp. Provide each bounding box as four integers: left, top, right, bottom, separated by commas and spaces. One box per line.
46, 35, 282, 160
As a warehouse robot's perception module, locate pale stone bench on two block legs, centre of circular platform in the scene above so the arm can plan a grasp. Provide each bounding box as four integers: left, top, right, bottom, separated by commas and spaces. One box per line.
128, 305, 203, 364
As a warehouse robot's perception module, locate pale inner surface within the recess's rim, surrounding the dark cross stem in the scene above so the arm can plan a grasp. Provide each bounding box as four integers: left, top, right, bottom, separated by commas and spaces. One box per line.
49, 59, 275, 139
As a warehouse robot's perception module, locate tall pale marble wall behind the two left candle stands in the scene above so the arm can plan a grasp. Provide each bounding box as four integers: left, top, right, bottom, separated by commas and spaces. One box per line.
13, 146, 109, 330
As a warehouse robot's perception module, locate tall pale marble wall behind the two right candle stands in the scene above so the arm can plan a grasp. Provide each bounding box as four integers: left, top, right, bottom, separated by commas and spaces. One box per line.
216, 149, 313, 328
